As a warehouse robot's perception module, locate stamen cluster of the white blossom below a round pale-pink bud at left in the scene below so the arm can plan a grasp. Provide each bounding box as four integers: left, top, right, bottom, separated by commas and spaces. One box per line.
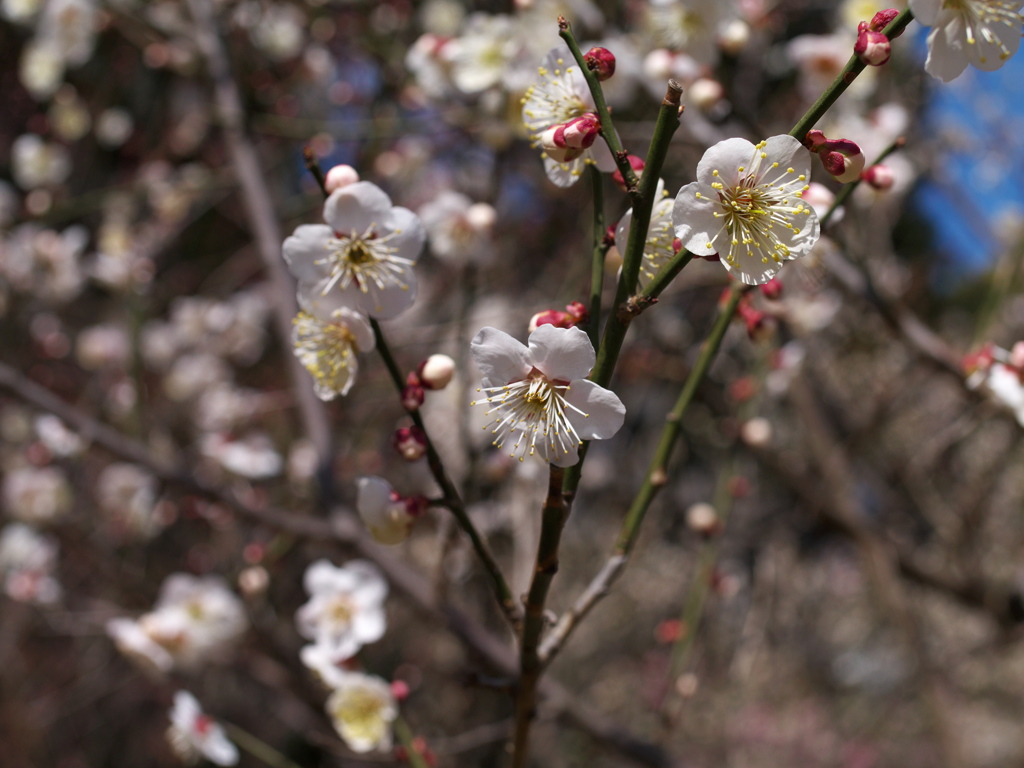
314, 224, 413, 296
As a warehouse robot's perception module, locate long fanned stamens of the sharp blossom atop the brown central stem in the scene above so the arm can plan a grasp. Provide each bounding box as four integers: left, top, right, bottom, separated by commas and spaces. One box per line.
470, 369, 587, 461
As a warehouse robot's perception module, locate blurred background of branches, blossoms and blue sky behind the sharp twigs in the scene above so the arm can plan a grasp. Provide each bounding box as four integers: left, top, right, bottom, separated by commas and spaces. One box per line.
0, 0, 1024, 768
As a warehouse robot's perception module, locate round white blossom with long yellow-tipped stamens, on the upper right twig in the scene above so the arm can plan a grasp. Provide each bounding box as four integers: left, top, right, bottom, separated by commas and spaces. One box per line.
673, 136, 819, 285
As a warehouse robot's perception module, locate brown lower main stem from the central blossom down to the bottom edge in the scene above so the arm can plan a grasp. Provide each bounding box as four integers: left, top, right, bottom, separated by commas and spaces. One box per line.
512, 464, 567, 768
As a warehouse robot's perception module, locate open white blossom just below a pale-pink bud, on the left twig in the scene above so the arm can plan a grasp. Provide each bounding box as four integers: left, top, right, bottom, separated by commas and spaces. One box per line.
284, 181, 426, 319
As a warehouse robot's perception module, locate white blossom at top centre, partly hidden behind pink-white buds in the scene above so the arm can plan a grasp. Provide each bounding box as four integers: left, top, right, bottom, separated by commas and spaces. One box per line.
522, 46, 615, 186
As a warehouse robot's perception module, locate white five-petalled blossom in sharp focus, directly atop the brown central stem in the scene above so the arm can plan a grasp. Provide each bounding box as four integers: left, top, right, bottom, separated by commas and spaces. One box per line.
470, 325, 626, 467
